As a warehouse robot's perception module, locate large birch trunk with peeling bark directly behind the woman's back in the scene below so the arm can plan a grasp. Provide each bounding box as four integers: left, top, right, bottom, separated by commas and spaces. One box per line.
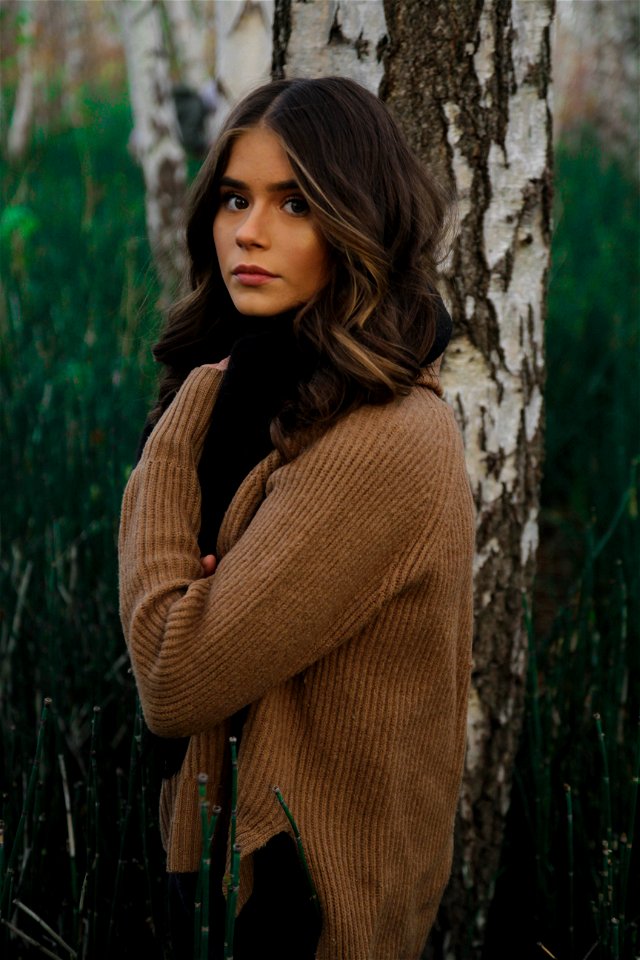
274, 0, 553, 960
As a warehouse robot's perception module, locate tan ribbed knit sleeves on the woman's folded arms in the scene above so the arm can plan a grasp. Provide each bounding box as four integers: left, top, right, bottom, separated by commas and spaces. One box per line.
120, 368, 460, 737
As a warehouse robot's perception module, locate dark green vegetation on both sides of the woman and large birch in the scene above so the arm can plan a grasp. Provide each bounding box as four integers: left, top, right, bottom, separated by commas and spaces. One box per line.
0, 94, 640, 960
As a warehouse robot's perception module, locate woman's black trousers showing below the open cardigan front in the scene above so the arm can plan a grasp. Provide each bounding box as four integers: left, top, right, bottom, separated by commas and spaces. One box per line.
169, 833, 322, 960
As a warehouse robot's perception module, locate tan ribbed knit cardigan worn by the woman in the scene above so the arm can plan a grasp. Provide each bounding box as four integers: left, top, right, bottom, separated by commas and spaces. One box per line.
120, 367, 474, 960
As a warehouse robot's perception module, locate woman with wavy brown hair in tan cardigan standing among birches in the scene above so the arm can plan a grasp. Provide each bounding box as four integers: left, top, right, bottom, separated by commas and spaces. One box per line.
120, 78, 474, 960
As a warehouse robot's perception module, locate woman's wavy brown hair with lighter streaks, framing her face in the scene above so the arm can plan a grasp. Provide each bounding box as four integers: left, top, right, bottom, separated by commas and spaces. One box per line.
152, 77, 451, 453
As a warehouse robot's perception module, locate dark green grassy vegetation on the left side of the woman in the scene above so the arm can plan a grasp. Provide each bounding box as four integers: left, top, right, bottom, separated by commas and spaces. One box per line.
0, 95, 162, 957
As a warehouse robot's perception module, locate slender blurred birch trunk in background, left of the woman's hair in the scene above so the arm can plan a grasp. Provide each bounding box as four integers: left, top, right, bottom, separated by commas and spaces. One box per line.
118, 0, 186, 297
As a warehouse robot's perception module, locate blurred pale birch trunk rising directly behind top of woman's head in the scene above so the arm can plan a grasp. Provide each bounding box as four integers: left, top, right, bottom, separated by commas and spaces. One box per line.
215, 0, 273, 131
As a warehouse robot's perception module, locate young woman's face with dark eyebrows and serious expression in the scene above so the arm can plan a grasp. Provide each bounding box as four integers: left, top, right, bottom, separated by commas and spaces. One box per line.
213, 127, 329, 317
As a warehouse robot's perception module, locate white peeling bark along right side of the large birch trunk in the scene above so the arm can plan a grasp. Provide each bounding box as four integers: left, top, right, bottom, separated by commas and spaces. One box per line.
444, 0, 551, 920
